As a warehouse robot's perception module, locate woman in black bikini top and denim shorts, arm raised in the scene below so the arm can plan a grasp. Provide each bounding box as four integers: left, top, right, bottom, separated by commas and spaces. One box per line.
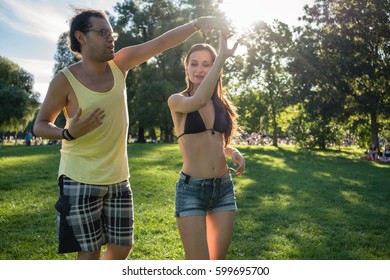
168, 31, 245, 259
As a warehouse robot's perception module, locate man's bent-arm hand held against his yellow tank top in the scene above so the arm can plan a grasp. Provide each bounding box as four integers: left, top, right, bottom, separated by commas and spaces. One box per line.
68, 108, 106, 139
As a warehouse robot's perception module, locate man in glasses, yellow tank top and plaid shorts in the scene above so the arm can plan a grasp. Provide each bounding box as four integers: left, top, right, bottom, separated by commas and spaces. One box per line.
34, 7, 227, 259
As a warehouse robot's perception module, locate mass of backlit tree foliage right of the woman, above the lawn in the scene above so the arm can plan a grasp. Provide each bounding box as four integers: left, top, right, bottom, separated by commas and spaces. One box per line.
230, 0, 390, 149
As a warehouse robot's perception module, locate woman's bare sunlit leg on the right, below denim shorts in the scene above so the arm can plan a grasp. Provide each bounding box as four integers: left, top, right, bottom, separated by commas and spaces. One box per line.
206, 211, 235, 260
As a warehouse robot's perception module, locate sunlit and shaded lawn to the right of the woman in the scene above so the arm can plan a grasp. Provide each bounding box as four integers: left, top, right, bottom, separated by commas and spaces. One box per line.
231, 147, 390, 259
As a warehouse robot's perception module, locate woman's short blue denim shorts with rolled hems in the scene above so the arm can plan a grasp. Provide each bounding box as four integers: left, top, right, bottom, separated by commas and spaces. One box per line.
176, 171, 237, 218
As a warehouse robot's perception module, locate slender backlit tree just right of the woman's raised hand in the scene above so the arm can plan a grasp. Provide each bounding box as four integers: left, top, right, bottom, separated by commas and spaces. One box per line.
241, 21, 292, 146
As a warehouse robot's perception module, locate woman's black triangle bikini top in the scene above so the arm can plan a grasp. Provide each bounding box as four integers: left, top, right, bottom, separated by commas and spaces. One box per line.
177, 93, 228, 139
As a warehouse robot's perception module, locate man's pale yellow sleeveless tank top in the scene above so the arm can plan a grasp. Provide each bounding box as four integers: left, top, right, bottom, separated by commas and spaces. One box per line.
58, 61, 130, 185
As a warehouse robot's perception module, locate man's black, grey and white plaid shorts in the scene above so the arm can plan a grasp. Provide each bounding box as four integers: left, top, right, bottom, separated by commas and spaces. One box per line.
55, 176, 134, 253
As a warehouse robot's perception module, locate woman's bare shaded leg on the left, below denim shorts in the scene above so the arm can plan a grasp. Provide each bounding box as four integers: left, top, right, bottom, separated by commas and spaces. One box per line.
176, 216, 209, 260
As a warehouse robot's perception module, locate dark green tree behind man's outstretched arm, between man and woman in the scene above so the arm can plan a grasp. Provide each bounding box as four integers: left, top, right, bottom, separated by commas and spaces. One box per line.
111, 0, 224, 142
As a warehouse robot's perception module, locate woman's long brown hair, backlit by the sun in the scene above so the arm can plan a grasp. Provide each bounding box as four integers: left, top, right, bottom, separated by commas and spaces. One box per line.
183, 44, 238, 147
